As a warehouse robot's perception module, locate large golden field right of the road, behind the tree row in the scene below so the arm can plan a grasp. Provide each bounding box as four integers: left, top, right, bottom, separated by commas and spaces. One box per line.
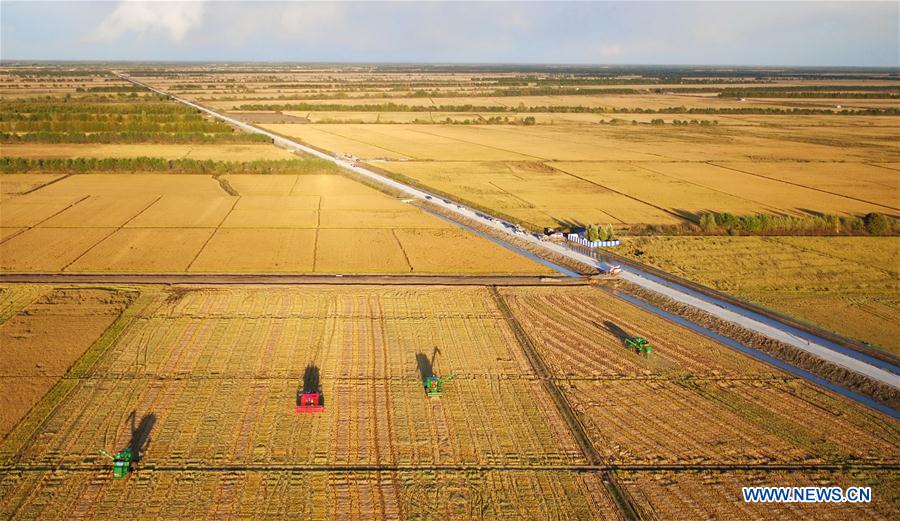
256, 124, 900, 228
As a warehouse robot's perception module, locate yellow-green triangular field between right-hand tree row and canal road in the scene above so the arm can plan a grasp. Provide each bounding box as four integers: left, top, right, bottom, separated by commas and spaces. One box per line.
621, 237, 900, 354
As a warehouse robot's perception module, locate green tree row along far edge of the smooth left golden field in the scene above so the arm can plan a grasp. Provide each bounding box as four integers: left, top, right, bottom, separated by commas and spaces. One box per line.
0, 157, 338, 174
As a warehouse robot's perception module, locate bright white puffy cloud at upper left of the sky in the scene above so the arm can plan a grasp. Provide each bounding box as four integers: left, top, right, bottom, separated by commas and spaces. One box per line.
94, 0, 204, 42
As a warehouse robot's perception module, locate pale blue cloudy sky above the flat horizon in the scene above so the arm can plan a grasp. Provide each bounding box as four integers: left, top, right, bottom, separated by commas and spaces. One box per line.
0, 0, 900, 67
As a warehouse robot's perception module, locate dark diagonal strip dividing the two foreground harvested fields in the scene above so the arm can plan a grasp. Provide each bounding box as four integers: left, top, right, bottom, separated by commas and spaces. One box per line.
490, 286, 645, 521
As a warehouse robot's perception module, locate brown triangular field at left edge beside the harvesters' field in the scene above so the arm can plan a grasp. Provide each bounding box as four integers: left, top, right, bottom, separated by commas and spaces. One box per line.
0, 287, 131, 437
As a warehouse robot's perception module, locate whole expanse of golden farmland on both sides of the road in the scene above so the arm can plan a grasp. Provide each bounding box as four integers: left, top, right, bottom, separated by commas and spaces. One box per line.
0, 63, 900, 520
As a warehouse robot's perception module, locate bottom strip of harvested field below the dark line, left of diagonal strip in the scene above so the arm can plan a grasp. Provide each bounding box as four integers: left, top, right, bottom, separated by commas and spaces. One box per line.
0, 470, 616, 520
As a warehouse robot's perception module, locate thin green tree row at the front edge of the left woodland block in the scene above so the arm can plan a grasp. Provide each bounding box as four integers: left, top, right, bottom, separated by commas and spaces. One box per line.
0, 132, 272, 144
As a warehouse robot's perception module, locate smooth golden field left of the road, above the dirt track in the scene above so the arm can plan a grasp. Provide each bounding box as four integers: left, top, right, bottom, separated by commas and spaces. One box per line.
0, 173, 551, 274
